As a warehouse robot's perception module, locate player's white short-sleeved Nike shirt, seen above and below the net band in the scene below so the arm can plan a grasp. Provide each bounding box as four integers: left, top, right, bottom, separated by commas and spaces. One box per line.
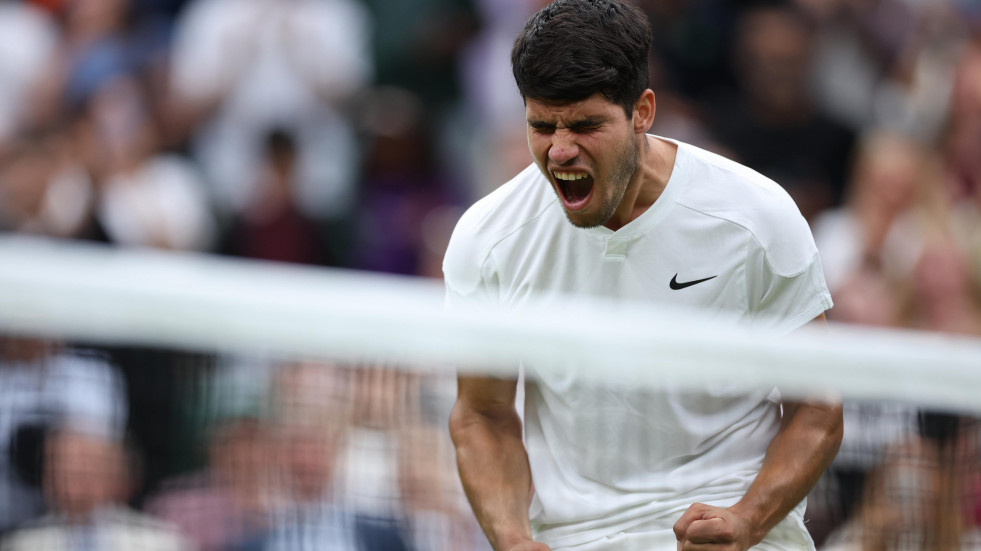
443, 138, 832, 546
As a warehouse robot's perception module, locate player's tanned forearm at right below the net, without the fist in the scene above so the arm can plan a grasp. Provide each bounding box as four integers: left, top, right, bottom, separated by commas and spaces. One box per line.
730, 403, 842, 542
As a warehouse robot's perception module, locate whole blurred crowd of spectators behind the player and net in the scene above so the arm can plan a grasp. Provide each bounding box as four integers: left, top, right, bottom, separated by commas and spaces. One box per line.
0, 0, 981, 551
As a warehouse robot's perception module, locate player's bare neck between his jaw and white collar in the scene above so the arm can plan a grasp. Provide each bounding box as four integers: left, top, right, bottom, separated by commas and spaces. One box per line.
605, 134, 678, 231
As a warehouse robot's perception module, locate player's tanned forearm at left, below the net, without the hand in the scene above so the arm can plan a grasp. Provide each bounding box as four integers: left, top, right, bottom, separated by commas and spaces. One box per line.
450, 402, 531, 551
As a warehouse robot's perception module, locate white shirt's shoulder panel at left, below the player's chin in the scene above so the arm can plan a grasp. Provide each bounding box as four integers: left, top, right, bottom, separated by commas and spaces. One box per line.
443, 164, 556, 294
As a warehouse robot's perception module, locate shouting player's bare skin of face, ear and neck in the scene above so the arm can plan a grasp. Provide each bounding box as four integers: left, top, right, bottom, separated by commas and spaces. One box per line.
525, 90, 677, 231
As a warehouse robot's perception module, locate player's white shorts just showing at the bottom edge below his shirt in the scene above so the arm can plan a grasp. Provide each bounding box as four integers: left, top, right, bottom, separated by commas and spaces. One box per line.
552, 517, 815, 551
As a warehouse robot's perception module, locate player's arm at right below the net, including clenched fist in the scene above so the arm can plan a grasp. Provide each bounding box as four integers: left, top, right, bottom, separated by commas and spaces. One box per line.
674, 314, 843, 551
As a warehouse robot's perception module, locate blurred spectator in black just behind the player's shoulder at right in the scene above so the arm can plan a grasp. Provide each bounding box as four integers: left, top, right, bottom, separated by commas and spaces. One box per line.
708, 7, 854, 220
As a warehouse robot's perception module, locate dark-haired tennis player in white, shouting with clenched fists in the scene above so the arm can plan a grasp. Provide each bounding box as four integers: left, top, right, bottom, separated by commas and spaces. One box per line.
443, 0, 842, 551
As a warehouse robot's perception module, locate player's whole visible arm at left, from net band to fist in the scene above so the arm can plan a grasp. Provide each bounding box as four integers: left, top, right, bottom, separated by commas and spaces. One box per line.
450, 377, 549, 551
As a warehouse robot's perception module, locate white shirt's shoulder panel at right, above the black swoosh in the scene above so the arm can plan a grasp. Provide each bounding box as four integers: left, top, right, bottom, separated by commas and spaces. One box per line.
678, 138, 817, 276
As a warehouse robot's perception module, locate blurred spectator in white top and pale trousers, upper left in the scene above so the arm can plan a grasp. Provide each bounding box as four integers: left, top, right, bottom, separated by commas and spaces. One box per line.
172, 0, 372, 222
